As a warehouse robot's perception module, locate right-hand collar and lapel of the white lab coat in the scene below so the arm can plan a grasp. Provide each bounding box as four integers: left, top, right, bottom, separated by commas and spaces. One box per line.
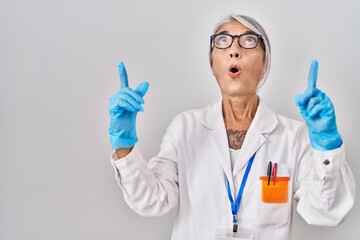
233, 98, 278, 178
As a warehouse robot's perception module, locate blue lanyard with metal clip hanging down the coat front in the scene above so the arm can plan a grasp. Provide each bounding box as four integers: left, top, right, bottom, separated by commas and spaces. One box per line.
226, 152, 256, 232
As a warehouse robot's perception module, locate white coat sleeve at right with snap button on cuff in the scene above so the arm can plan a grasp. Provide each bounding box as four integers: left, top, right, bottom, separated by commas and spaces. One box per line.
294, 127, 355, 227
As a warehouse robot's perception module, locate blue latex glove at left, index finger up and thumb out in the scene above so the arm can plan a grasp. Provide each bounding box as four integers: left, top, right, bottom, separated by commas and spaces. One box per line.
109, 62, 149, 150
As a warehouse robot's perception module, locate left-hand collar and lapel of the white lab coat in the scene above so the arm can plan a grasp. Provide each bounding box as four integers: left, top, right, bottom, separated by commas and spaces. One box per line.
201, 99, 234, 191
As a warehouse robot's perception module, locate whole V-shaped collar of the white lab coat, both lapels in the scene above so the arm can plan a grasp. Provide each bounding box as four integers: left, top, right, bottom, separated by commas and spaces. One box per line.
200, 98, 278, 191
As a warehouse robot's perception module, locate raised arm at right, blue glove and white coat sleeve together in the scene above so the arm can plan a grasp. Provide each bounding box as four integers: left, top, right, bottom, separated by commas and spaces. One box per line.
294, 60, 355, 227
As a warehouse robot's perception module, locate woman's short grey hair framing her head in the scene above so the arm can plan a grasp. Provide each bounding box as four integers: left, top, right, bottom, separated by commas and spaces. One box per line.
209, 14, 271, 88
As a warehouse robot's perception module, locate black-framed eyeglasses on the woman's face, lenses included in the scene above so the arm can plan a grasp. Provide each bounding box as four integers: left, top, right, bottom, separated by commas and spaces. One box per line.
210, 33, 262, 49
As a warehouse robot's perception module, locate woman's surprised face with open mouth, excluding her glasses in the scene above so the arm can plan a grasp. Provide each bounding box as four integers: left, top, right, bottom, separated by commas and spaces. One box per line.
211, 21, 265, 97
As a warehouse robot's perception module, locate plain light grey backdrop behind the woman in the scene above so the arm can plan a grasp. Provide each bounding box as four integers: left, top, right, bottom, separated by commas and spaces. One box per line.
0, 0, 360, 240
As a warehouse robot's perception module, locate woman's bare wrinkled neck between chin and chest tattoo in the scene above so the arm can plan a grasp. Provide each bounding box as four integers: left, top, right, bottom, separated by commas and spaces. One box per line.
222, 94, 259, 127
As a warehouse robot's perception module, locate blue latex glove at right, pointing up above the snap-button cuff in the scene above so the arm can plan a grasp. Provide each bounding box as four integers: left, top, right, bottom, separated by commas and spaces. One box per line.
295, 60, 342, 151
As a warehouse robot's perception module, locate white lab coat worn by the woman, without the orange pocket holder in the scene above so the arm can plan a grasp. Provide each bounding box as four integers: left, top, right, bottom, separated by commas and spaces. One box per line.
112, 99, 355, 240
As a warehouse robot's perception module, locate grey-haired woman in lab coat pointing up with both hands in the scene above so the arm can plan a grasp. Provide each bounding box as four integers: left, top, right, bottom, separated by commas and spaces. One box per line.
109, 15, 355, 240
